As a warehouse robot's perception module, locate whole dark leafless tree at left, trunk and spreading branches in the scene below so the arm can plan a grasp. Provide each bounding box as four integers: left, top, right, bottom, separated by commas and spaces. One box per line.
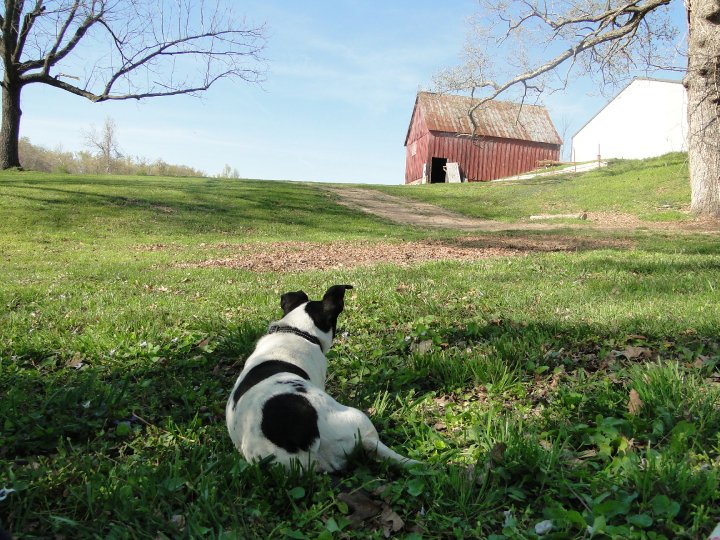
0, 0, 265, 169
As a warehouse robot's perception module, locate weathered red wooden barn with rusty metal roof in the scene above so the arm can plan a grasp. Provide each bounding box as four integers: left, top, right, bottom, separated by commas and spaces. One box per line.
405, 92, 562, 184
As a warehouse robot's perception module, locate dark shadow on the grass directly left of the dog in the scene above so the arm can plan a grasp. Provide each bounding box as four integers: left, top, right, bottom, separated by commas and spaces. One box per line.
0, 325, 265, 459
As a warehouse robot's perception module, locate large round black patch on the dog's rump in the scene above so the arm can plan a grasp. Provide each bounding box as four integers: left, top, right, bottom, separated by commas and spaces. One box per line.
260, 394, 320, 454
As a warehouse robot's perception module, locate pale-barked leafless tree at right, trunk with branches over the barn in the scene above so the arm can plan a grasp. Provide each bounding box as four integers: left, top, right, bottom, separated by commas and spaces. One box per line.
436, 0, 720, 217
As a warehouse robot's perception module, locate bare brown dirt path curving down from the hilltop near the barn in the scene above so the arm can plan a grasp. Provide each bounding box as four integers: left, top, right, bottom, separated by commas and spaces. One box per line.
328, 187, 720, 233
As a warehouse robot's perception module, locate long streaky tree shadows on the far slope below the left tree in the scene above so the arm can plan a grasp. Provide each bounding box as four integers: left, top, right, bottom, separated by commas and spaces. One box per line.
4, 181, 410, 235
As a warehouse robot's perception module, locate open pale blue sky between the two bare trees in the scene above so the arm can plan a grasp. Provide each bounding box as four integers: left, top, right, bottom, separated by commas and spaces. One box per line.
21, 0, 683, 184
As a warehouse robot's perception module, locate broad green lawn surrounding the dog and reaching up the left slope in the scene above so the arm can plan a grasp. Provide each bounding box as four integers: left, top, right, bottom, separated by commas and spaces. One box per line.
0, 165, 720, 539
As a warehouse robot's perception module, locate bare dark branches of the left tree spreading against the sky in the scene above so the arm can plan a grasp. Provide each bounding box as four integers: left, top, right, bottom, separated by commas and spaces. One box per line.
3, 0, 265, 97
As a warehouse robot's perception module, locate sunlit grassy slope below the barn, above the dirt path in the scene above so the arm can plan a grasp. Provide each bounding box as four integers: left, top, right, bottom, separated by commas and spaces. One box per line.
377, 153, 690, 221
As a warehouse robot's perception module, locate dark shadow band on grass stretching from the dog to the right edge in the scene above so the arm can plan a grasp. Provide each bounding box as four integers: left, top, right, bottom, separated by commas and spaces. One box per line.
346, 316, 720, 403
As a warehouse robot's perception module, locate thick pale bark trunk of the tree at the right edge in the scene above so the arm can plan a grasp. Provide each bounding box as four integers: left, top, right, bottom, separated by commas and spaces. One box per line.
685, 0, 720, 217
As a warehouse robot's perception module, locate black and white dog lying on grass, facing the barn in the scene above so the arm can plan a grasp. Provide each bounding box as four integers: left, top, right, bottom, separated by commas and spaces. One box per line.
225, 285, 417, 471
